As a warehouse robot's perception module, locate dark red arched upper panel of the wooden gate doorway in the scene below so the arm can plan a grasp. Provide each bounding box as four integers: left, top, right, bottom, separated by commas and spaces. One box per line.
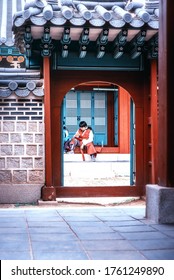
53, 70, 144, 107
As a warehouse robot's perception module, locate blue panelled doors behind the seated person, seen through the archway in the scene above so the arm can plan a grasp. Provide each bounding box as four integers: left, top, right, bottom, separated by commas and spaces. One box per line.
63, 90, 107, 145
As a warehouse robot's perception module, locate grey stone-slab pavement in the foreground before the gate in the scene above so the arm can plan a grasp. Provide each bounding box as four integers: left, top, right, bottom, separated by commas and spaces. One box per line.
0, 206, 174, 260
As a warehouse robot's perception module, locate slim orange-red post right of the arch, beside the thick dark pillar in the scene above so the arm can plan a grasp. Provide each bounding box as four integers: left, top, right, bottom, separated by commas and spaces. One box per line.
150, 60, 158, 184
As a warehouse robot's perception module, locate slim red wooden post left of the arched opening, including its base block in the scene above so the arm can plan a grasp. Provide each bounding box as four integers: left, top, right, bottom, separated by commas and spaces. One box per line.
42, 57, 56, 200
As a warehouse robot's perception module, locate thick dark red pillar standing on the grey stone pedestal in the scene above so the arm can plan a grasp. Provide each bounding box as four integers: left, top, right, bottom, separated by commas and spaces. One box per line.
158, 0, 174, 187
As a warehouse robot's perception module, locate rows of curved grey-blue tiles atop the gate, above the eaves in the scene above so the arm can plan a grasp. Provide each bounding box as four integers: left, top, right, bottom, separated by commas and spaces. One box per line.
14, 0, 159, 29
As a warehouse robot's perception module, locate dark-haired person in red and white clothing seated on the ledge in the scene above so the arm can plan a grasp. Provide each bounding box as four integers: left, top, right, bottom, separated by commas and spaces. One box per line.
70, 121, 97, 161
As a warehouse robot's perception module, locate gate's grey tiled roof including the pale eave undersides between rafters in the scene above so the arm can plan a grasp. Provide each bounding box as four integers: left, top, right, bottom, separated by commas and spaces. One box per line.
10, 0, 159, 57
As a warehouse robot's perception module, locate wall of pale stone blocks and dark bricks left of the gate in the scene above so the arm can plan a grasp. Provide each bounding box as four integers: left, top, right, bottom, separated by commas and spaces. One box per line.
0, 94, 45, 185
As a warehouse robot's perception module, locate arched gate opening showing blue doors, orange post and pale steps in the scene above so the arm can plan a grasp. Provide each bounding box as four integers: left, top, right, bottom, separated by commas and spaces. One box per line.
62, 82, 136, 187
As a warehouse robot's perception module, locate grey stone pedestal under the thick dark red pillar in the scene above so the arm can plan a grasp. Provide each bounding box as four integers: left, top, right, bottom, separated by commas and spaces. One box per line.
146, 185, 174, 224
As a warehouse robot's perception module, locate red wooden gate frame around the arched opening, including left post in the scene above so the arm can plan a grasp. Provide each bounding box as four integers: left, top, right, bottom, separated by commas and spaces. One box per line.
42, 58, 149, 200
